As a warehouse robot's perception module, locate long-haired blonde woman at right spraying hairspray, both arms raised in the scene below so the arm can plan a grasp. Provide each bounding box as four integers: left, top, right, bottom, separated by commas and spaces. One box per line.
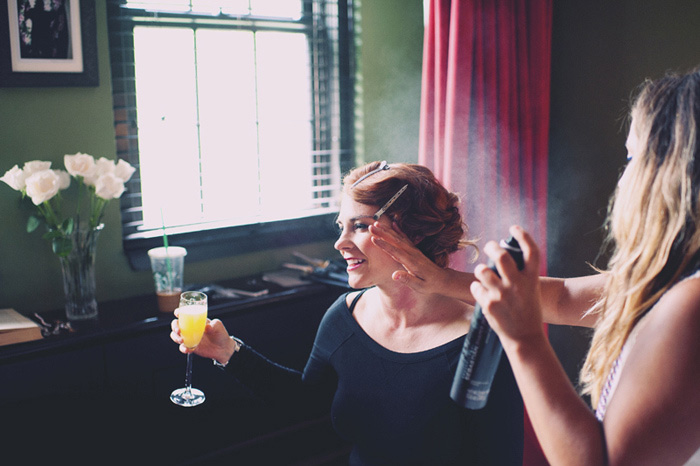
370, 69, 700, 466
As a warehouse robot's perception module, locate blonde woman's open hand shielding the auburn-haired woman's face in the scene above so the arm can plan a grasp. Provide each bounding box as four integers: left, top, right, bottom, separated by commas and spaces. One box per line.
369, 222, 474, 304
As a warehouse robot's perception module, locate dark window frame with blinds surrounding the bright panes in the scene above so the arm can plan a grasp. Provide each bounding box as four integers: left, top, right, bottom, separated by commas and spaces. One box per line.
107, 0, 357, 270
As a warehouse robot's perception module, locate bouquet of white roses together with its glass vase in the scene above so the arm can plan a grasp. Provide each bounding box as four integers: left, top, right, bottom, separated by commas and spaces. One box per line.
0, 152, 135, 321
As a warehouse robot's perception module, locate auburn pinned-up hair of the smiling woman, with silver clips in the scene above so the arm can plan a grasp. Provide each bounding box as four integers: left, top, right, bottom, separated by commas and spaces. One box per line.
343, 162, 476, 267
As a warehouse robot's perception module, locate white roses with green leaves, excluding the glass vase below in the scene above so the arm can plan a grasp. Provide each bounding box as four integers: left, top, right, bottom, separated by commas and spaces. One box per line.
0, 152, 135, 257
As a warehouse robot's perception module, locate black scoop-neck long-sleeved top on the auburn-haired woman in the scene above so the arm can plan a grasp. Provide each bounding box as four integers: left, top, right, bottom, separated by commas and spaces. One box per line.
227, 293, 523, 466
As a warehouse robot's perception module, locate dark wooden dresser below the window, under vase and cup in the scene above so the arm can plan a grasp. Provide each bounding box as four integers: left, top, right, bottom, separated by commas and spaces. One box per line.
0, 277, 349, 465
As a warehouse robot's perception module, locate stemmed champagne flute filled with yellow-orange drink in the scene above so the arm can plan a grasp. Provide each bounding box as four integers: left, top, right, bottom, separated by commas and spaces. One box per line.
170, 291, 207, 407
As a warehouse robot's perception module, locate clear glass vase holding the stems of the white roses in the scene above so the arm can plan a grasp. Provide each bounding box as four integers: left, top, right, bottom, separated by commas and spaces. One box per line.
60, 224, 104, 321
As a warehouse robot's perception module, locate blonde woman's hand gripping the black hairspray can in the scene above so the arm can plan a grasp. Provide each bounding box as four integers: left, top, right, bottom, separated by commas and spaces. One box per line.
470, 226, 544, 345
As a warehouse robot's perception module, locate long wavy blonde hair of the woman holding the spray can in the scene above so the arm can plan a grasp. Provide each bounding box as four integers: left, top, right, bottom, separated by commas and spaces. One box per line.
580, 70, 700, 406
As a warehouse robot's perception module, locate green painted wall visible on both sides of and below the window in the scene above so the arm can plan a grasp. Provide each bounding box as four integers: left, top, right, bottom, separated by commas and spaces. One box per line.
0, 0, 423, 314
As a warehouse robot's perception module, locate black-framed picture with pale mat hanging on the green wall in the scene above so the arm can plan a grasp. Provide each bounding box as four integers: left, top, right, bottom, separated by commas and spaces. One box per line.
0, 0, 99, 87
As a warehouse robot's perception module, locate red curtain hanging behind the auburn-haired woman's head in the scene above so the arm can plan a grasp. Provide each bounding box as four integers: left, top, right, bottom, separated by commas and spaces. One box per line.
419, 0, 552, 466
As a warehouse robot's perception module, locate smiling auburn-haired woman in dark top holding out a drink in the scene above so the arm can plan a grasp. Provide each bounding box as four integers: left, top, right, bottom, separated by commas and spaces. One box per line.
171, 162, 523, 466
